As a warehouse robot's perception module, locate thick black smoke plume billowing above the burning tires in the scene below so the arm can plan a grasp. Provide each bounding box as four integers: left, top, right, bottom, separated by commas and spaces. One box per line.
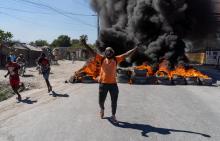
91, 0, 216, 66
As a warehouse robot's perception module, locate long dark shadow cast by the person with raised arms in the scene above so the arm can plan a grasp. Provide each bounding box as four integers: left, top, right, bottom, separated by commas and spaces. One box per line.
106, 118, 211, 138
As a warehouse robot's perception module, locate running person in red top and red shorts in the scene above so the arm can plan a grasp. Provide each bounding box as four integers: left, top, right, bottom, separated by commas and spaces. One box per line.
5, 57, 25, 101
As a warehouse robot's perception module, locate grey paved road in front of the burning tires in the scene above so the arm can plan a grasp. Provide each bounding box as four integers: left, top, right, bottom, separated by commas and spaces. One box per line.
0, 62, 220, 141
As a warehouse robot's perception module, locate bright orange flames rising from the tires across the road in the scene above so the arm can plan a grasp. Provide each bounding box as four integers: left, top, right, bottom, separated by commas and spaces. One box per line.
74, 58, 209, 84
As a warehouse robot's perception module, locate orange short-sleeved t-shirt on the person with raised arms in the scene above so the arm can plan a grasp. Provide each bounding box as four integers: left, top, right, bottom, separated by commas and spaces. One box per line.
95, 54, 125, 84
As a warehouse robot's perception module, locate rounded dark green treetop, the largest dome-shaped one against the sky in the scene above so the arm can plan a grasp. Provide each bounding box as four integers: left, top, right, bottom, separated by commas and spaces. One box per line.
51, 35, 71, 47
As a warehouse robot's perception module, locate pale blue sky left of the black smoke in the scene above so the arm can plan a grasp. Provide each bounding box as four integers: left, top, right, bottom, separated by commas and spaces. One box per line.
0, 0, 97, 43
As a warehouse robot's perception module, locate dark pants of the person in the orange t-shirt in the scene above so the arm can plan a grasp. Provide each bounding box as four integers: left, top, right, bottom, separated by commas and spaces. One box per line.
99, 83, 119, 115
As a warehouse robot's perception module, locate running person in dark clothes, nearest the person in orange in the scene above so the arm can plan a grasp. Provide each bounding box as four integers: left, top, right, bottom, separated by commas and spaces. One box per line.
38, 53, 52, 93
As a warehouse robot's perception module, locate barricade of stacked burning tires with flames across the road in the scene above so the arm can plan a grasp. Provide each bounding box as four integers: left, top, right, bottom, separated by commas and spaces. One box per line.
69, 58, 213, 86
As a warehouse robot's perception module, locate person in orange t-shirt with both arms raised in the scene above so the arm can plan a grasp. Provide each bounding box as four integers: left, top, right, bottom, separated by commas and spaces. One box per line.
81, 40, 137, 122
